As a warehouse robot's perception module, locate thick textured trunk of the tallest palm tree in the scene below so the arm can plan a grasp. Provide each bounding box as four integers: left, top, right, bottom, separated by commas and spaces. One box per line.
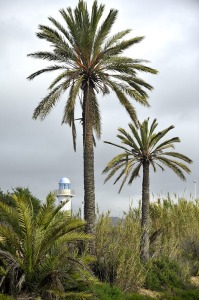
83, 84, 95, 238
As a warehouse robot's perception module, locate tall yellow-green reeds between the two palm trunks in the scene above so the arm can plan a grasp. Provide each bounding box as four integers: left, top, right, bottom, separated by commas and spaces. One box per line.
95, 209, 145, 291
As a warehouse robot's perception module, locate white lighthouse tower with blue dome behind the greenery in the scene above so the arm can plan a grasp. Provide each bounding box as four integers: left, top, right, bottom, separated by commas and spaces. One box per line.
55, 177, 75, 215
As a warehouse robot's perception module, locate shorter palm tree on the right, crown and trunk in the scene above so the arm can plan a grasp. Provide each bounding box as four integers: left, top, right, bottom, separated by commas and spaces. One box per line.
103, 118, 192, 262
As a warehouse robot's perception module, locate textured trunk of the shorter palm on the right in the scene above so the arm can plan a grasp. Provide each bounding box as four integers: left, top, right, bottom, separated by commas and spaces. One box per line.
140, 160, 149, 263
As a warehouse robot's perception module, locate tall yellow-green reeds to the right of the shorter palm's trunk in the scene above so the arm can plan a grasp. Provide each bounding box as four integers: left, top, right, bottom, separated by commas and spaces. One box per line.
150, 195, 199, 275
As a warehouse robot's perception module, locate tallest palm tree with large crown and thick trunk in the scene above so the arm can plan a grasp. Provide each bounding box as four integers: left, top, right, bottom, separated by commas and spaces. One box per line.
28, 0, 157, 233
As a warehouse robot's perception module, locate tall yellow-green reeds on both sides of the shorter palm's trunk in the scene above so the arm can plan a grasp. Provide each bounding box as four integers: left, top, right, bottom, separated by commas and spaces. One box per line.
94, 195, 199, 291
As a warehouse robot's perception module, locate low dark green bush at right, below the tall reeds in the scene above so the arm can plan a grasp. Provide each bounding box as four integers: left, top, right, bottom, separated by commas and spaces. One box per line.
145, 258, 185, 291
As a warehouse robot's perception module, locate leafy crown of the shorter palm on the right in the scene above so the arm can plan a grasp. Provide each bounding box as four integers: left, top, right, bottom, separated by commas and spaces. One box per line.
103, 118, 192, 192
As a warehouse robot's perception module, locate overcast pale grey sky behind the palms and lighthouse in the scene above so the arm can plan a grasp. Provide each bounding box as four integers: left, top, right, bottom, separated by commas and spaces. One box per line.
0, 0, 199, 216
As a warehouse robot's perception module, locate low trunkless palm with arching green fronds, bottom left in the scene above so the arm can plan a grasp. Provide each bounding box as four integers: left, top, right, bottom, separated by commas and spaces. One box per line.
0, 194, 96, 300
